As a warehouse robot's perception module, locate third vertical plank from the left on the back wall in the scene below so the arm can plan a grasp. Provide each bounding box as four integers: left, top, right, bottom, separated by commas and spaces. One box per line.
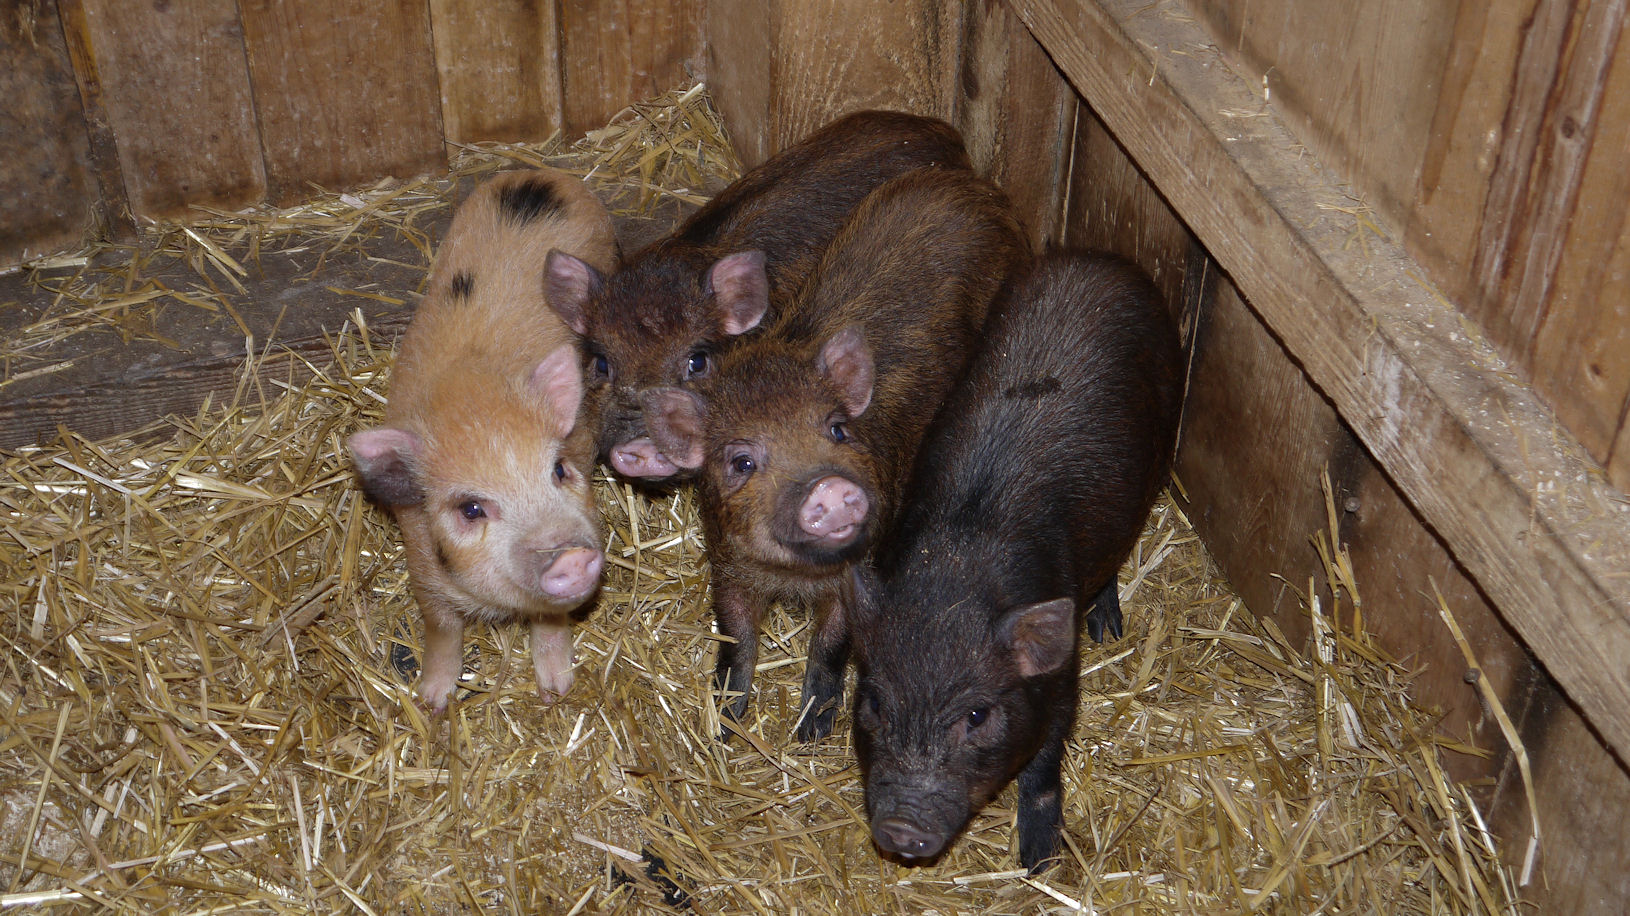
238, 0, 447, 204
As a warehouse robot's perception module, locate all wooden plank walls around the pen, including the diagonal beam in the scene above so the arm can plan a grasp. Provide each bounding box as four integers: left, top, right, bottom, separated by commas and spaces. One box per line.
0, 0, 1630, 913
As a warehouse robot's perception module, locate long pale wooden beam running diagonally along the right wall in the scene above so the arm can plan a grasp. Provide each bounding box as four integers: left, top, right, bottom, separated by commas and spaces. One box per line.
1011, 0, 1630, 761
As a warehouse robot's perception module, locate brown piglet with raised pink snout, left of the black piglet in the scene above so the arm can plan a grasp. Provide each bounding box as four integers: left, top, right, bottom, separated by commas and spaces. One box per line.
645, 170, 1029, 740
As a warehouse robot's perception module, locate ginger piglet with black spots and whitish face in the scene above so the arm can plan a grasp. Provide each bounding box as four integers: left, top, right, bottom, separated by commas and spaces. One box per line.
349, 170, 616, 712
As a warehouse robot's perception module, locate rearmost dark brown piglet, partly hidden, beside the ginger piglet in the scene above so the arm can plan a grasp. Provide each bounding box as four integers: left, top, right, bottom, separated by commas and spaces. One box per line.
549, 111, 968, 482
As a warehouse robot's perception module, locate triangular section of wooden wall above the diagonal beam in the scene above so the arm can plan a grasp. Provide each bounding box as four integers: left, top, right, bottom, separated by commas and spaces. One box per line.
1185, 0, 1630, 489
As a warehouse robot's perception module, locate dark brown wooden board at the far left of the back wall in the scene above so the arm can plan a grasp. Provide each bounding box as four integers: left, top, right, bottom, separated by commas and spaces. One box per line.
0, 0, 98, 269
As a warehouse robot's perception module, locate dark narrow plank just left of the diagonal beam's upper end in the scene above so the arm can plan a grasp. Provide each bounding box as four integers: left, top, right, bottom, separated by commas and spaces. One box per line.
957, 0, 1076, 246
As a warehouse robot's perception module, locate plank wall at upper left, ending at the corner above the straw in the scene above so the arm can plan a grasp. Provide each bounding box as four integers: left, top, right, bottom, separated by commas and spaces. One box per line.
0, 0, 703, 269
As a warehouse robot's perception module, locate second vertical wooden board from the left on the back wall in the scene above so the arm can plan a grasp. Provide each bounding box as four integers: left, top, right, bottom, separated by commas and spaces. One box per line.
74, 0, 266, 218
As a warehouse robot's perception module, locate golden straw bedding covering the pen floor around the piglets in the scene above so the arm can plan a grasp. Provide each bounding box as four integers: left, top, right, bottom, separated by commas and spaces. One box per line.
0, 90, 1516, 914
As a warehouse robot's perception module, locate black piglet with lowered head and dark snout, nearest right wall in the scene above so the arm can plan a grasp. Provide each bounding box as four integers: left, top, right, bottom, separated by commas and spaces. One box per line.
849, 253, 1182, 870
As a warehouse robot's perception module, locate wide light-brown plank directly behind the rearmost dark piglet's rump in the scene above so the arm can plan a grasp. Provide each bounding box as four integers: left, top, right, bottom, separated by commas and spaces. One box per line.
769, 0, 962, 150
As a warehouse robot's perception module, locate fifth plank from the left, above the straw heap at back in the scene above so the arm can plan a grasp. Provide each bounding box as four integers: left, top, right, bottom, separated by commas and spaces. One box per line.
561, 0, 703, 132
